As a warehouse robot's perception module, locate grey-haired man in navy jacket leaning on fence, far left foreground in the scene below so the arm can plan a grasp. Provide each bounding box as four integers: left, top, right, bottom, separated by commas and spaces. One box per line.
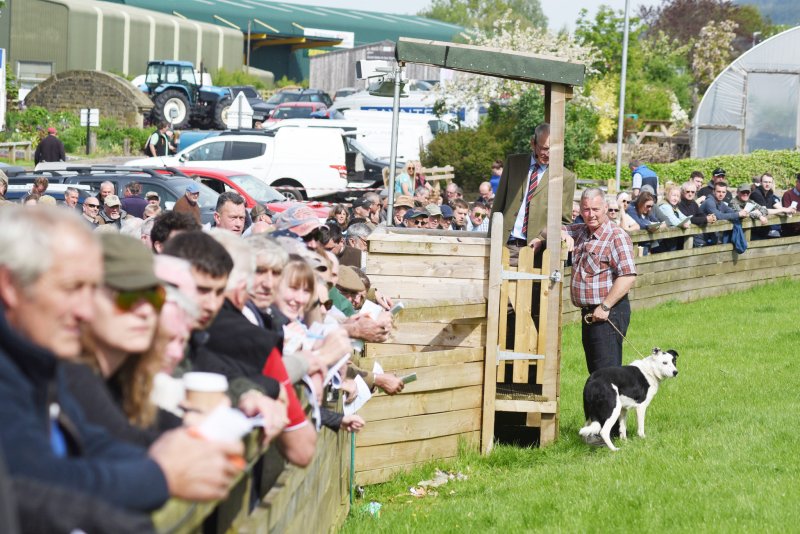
0, 208, 243, 511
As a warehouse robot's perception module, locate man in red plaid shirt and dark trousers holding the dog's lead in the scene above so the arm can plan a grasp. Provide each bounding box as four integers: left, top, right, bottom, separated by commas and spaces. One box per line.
552, 188, 636, 374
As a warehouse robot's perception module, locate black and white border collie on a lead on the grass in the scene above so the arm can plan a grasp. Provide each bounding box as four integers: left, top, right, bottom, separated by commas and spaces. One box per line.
578, 348, 678, 451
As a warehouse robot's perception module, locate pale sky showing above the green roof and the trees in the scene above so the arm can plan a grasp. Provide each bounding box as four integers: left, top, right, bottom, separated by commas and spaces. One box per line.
285, 0, 661, 31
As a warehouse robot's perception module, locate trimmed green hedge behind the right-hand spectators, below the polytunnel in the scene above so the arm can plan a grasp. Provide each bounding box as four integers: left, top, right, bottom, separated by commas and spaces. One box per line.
573, 150, 800, 189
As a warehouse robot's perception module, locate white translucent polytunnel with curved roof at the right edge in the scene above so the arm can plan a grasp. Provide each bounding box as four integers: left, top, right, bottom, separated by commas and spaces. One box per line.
692, 26, 800, 158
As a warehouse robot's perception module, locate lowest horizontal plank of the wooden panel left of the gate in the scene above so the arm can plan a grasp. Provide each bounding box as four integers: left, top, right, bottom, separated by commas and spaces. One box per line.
356, 432, 480, 472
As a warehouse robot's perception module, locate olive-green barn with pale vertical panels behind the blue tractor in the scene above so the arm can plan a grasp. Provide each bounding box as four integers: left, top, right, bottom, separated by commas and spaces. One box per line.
0, 0, 244, 95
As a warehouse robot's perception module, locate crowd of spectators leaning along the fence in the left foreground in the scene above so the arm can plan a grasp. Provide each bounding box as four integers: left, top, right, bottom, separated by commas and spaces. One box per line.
0, 172, 418, 532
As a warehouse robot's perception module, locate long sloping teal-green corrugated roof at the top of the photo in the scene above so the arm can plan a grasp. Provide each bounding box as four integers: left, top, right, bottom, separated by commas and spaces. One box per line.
105, 0, 464, 46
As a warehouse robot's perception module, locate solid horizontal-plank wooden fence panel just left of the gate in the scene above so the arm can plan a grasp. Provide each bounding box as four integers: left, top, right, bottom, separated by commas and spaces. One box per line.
355, 229, 489, 484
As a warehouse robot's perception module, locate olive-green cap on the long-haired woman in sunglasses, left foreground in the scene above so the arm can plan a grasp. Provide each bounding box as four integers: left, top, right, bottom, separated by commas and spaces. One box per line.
100, 236, 160, 291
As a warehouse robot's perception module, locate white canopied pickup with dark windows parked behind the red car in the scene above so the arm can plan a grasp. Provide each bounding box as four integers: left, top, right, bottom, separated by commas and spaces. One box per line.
125, 128, 347, 200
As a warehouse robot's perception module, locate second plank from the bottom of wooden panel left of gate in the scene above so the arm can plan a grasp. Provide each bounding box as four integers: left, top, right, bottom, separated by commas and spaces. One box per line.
358, 408, 481, 447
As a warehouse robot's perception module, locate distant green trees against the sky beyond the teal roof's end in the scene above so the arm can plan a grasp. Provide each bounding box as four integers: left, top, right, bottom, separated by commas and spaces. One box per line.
418, 0, 547, 32
